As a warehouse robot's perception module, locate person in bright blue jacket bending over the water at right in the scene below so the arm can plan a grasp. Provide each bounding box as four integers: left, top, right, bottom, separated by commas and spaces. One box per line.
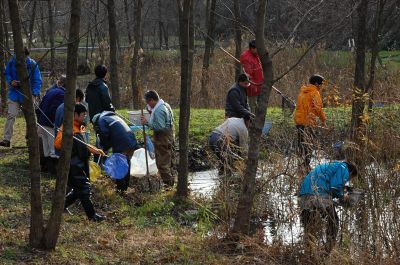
299, 161, 357, 253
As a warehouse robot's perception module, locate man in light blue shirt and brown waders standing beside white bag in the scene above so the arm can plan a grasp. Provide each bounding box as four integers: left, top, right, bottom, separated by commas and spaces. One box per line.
141, 90, 176, 187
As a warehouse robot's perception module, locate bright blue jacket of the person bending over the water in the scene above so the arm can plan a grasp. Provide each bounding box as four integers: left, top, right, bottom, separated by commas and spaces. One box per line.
299, 161, 350, 198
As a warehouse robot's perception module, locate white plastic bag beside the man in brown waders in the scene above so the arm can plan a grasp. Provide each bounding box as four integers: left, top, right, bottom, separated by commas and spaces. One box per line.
130, 148, 158, 178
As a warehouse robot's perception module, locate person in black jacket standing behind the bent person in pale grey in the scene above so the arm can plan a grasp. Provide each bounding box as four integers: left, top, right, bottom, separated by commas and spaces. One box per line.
225, 74, 254, 118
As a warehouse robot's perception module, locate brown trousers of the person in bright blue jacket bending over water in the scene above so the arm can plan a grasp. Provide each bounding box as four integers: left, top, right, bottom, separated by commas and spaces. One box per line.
300, 206, 339, 253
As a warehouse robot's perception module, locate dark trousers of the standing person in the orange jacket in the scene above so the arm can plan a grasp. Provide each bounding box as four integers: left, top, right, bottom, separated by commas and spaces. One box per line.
296, 125, 315, 169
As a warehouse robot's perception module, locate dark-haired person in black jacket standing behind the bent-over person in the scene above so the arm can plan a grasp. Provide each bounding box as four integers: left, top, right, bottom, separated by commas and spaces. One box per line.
86, 65, 115, 121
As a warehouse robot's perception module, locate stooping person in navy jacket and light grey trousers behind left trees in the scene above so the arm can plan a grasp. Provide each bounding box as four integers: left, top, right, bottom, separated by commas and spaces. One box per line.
38, 75, 66, 174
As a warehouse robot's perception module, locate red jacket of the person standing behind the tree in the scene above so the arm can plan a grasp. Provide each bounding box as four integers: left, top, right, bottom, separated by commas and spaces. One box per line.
240, 49, 264, 97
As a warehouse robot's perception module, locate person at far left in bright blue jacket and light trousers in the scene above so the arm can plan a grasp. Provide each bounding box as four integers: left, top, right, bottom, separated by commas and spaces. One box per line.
0, 47, 42, 147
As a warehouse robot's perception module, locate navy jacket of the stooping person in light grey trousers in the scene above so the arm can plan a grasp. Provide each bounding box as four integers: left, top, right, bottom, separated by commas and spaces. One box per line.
38, 85, 65, 127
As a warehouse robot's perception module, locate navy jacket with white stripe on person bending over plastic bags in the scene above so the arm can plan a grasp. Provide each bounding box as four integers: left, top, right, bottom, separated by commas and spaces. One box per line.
95, 111, 138, 153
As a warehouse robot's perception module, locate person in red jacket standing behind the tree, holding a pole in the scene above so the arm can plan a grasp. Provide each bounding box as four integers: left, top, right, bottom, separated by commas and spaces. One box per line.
240, 40, 264, 112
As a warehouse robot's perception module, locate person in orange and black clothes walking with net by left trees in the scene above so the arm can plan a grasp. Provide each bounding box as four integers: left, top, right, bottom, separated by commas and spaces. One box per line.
54, 104, 105, 222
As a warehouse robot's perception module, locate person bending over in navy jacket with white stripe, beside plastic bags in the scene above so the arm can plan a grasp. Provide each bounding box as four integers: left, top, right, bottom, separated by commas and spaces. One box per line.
93, 111, 139, 192
